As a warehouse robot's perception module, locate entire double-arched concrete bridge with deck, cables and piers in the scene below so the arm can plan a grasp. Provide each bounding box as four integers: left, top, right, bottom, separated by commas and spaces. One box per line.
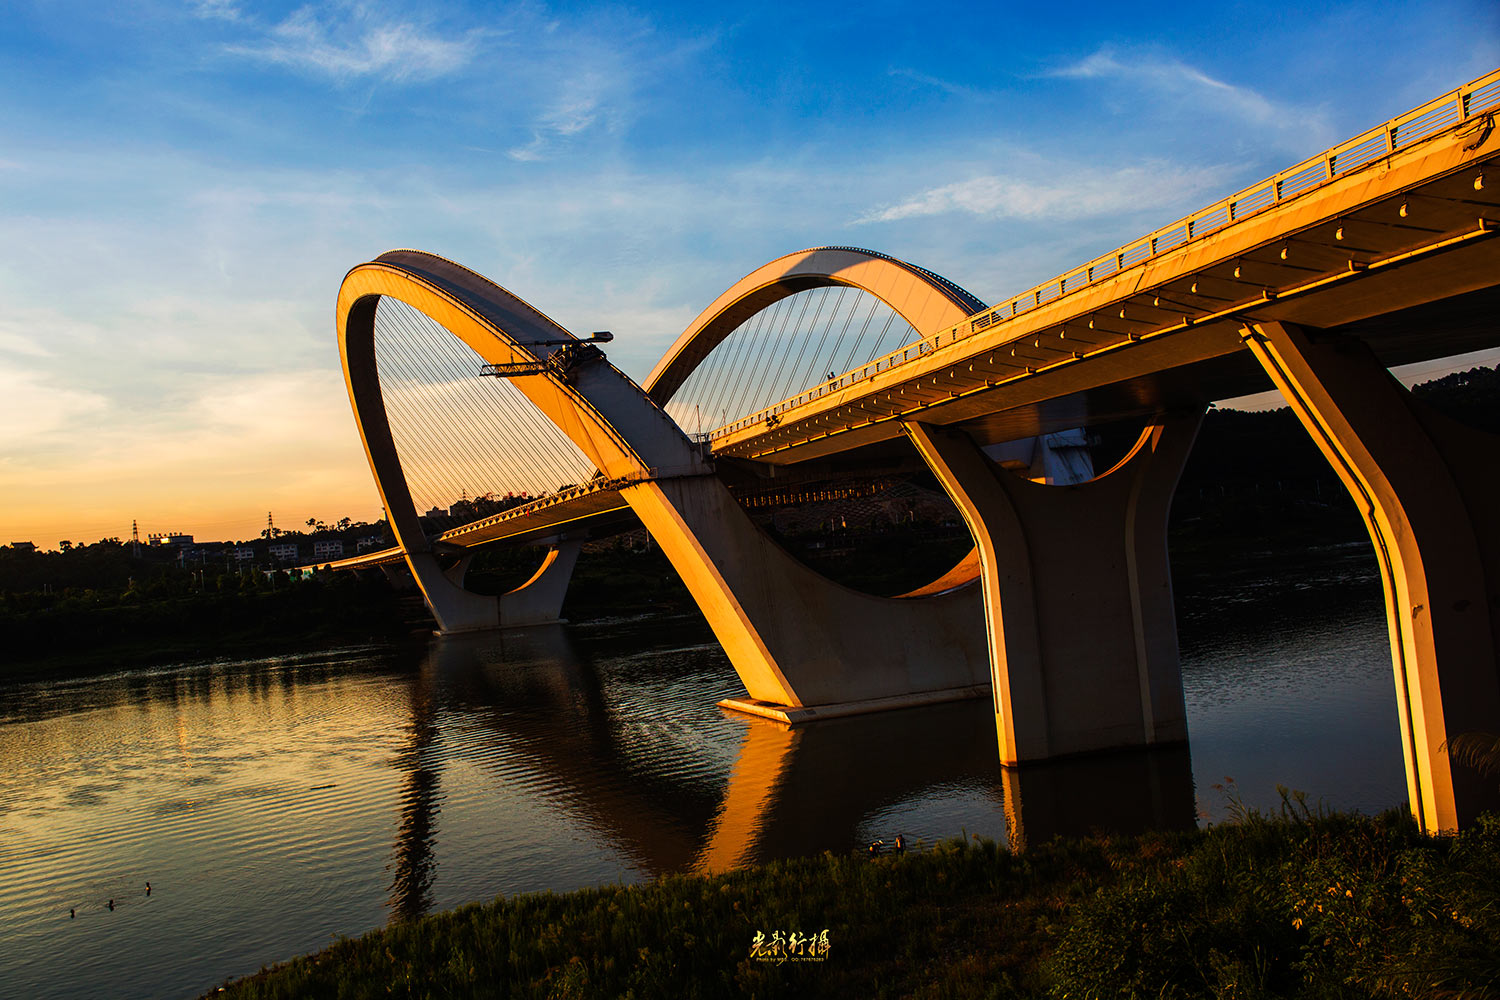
322, 70, 1500, 831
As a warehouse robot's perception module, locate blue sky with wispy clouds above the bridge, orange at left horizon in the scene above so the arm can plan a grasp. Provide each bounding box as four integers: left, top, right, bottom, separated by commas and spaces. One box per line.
0, 0, 1500, 546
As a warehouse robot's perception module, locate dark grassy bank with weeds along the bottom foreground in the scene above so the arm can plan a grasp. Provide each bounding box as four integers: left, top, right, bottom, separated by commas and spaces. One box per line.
216, 801, 1500, 1000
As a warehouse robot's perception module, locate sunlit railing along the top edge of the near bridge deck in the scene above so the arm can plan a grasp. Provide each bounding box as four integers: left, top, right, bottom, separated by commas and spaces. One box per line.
710, 69, 1500, 439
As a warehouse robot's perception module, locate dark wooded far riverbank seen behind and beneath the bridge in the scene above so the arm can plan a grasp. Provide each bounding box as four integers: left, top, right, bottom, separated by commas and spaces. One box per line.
11, 369, 1500, 669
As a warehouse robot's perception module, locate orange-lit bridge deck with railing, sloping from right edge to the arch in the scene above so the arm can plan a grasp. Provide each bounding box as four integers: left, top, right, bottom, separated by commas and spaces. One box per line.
713, 72, 1500, 465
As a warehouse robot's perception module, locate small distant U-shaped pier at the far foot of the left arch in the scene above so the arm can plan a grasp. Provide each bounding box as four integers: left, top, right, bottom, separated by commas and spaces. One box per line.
407, 535, 584, 634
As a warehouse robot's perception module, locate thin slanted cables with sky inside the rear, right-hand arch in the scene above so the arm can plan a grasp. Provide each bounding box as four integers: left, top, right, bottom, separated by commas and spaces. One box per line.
666, 285, 917, 433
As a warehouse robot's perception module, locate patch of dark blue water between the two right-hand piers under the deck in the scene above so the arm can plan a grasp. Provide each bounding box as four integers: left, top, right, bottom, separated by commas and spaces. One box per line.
1178, 546, 1407, 820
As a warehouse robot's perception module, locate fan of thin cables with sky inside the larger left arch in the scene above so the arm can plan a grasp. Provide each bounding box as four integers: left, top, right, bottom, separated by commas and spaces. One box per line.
375, 295, 596, 531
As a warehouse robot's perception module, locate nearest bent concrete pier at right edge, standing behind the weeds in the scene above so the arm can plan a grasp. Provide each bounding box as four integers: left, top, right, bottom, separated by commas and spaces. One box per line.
1244, 322, 1500, 832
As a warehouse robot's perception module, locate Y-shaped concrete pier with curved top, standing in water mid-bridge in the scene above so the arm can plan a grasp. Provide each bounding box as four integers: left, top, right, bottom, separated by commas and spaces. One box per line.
905, 412, 1202, 765
